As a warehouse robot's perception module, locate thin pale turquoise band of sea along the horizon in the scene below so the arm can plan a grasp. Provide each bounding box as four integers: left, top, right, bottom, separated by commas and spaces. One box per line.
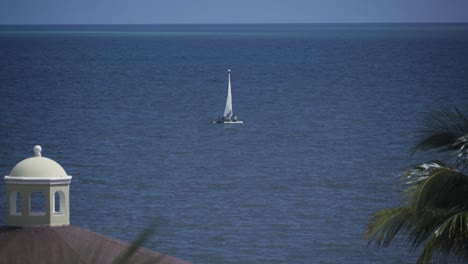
0, 23, 468, 37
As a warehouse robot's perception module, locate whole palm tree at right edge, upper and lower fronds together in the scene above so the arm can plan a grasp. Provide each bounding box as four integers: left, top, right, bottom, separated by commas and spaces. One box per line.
365, 108, 468, 263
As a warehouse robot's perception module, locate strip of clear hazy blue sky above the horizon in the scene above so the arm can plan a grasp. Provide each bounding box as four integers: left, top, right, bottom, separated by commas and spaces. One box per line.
0, 0, 468, 24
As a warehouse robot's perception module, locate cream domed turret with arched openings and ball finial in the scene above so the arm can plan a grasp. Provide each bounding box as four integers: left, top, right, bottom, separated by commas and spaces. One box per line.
5, 146, 72, 226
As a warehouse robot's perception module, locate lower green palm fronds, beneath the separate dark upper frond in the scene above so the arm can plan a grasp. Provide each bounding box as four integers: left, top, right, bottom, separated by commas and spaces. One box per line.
365, 161, 468, 263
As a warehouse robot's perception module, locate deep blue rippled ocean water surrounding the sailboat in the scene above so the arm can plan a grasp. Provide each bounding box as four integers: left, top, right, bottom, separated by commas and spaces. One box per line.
0, 24, 468, 263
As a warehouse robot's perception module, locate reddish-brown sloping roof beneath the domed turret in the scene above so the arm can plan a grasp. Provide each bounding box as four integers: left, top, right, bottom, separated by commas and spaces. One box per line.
0, 225, 192, 264
